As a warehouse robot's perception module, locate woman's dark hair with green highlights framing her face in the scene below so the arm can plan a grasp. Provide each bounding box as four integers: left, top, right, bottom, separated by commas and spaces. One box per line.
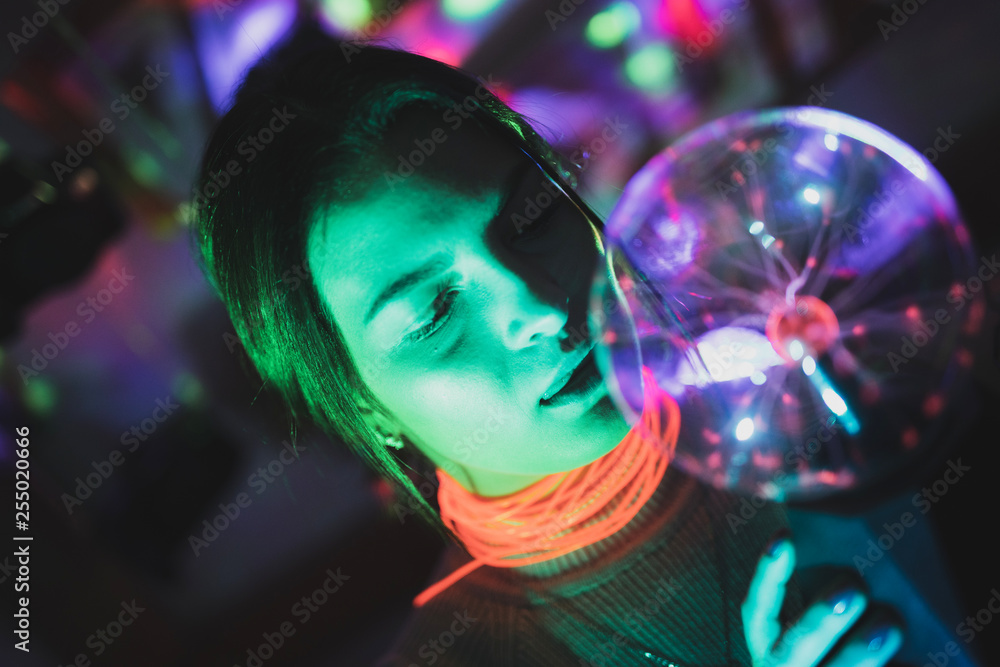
191, 26, 600, 539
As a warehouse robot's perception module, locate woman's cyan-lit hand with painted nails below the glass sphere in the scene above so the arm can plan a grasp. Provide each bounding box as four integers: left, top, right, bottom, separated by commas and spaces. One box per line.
742, 536, 903, 667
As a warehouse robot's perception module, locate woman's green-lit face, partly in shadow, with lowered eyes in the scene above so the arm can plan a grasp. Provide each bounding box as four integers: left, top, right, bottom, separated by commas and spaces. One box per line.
308, 112, 628, 495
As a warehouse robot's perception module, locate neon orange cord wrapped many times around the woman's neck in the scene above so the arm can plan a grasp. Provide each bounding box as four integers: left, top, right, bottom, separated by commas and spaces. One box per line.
413, 366, 680, 607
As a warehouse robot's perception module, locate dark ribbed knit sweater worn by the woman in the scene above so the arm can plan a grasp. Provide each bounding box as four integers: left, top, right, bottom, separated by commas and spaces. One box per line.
376, 466, 802, 667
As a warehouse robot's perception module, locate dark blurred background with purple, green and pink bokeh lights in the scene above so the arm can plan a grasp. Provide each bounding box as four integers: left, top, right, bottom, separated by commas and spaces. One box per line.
0, 0, 1000, 667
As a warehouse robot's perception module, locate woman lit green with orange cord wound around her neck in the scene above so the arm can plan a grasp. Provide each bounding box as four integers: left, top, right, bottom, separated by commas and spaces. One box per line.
188, 23, 901, 666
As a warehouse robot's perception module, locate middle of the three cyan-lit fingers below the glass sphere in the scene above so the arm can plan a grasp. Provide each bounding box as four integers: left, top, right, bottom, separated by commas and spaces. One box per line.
774, 586, 868, 666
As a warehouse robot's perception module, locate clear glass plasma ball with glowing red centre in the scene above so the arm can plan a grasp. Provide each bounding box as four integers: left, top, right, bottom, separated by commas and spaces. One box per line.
590, 107, 988, 501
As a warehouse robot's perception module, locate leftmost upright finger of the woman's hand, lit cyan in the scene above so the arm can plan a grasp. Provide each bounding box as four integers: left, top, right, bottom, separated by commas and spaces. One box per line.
742, 535, 795, 659
